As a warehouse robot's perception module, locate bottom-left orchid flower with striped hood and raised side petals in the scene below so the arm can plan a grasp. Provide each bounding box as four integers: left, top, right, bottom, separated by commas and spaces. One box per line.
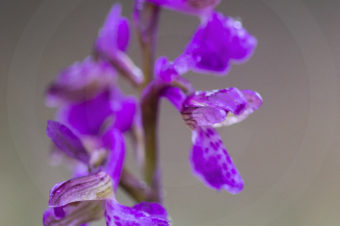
43, 121, 169, 226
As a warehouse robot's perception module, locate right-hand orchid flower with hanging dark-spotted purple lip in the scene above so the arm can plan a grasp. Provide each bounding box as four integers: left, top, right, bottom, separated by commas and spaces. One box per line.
163, 87, 262, 194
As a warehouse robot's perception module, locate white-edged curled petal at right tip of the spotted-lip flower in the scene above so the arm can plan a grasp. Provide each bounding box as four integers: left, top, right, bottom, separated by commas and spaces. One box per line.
214, 90, 263, 127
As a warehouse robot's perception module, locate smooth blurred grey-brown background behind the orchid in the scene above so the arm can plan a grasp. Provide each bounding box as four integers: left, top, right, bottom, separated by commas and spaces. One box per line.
0, 0, 340, 226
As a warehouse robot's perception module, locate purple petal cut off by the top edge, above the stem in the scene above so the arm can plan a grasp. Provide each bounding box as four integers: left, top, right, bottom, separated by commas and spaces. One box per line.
147, 0, 220, 15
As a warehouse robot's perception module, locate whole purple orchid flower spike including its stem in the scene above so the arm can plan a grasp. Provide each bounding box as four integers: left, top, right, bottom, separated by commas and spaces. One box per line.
43, 0, 262, 226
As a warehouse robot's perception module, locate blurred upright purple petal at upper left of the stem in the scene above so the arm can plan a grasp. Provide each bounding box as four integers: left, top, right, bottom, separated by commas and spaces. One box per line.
95, 4, 130, 58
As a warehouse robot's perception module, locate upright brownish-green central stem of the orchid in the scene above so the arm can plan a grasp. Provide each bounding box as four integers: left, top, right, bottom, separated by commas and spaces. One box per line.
135, 3, 162, 203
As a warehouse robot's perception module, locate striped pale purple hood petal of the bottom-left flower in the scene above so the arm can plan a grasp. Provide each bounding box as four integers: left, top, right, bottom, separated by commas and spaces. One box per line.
49, 172, 113, 207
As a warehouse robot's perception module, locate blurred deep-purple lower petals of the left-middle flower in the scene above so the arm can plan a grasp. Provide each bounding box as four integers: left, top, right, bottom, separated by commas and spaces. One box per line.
57, 88, 137, 135
